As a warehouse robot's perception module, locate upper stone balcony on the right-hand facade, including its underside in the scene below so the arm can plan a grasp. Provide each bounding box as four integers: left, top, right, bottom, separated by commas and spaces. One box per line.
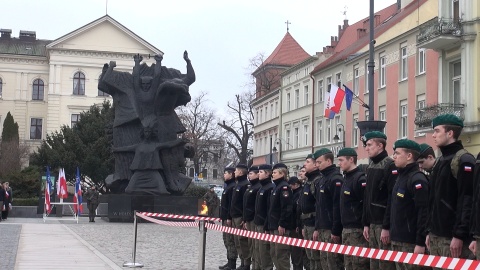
417, 17, 463, 50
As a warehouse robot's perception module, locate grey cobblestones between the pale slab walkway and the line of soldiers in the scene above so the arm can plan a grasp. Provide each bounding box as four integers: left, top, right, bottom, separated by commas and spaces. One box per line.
64, 219, 229, 270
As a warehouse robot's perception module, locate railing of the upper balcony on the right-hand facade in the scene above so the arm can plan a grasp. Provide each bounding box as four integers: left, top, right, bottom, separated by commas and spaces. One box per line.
417, 18, 463, 44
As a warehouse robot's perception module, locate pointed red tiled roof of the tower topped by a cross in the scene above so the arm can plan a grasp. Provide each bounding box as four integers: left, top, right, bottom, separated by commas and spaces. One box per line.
263, 32, 310, 66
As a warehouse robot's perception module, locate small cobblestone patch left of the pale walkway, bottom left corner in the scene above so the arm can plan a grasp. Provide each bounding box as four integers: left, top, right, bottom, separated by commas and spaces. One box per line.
0, 224, 22, 269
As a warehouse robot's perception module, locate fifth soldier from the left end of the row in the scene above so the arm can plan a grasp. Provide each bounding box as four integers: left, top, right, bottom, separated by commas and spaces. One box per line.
265, 163, 295, 270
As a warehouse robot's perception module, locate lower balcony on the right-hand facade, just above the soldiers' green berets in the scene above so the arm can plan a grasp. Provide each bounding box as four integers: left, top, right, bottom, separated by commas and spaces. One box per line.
415, 103, 465, 129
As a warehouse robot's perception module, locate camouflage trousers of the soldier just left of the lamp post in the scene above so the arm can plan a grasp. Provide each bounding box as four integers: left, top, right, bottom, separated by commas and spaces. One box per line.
342, 228, 370, 270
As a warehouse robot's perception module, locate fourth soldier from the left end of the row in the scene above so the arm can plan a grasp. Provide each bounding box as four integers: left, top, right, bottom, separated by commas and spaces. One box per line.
253, 164, 275, 270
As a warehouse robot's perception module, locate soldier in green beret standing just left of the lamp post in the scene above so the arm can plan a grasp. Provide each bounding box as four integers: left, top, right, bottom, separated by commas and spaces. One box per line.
337, 148, 370, 270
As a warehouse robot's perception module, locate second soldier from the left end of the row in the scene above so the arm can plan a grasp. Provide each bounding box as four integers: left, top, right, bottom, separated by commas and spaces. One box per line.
230, 164, 251, 270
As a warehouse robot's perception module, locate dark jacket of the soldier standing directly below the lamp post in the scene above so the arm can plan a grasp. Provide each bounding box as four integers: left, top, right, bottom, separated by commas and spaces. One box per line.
362, 151, 397, 230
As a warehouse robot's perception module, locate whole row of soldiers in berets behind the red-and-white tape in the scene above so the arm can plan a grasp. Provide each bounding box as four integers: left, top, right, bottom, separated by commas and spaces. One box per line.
219, 115, 480, 270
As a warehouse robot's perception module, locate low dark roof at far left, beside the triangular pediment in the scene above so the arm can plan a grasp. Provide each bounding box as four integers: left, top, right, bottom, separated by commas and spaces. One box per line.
0, 38, 51, 56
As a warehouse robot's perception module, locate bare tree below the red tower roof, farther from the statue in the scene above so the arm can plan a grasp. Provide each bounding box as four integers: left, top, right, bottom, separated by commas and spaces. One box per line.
218, 91, 254, 164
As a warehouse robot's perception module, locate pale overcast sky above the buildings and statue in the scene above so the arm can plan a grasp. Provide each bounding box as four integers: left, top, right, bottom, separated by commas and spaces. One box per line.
0, 0, 396, 114
